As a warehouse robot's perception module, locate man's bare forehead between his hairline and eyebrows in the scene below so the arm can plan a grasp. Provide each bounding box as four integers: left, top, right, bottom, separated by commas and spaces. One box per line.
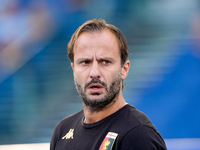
74, 29, 120, 57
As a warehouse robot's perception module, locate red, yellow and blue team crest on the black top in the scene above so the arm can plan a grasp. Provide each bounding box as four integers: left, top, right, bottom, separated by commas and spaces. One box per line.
99, 132, 118, 150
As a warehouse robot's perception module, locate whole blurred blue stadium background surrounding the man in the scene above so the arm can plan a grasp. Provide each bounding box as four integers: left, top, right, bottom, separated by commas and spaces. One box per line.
0, 0, 200, 150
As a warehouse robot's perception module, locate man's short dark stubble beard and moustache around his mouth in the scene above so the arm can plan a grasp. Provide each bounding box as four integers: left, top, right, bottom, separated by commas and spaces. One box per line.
74, 73, 121, 111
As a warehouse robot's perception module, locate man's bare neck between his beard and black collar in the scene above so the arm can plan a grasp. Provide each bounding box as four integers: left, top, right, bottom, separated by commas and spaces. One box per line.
83, 93, 126, 124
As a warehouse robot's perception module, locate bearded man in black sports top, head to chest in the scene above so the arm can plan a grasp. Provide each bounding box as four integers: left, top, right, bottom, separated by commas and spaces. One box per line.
50, 19, 166, 150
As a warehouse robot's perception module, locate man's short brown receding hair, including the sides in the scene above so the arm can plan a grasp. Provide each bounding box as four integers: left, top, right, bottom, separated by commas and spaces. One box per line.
68, 19, 129, 66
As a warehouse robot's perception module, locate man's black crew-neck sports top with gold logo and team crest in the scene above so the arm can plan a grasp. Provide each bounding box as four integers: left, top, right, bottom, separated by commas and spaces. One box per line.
50, 104, 167, 150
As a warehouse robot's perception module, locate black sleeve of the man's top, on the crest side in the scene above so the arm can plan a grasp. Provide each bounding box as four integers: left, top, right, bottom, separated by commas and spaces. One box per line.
120, 125, 167, 150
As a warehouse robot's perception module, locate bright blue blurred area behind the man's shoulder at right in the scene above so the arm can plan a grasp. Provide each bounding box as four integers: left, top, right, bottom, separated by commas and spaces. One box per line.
132, 41, 200, 138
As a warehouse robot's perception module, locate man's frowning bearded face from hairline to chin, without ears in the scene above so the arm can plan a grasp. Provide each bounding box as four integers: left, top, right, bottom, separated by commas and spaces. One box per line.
72, 30, 122, 111
